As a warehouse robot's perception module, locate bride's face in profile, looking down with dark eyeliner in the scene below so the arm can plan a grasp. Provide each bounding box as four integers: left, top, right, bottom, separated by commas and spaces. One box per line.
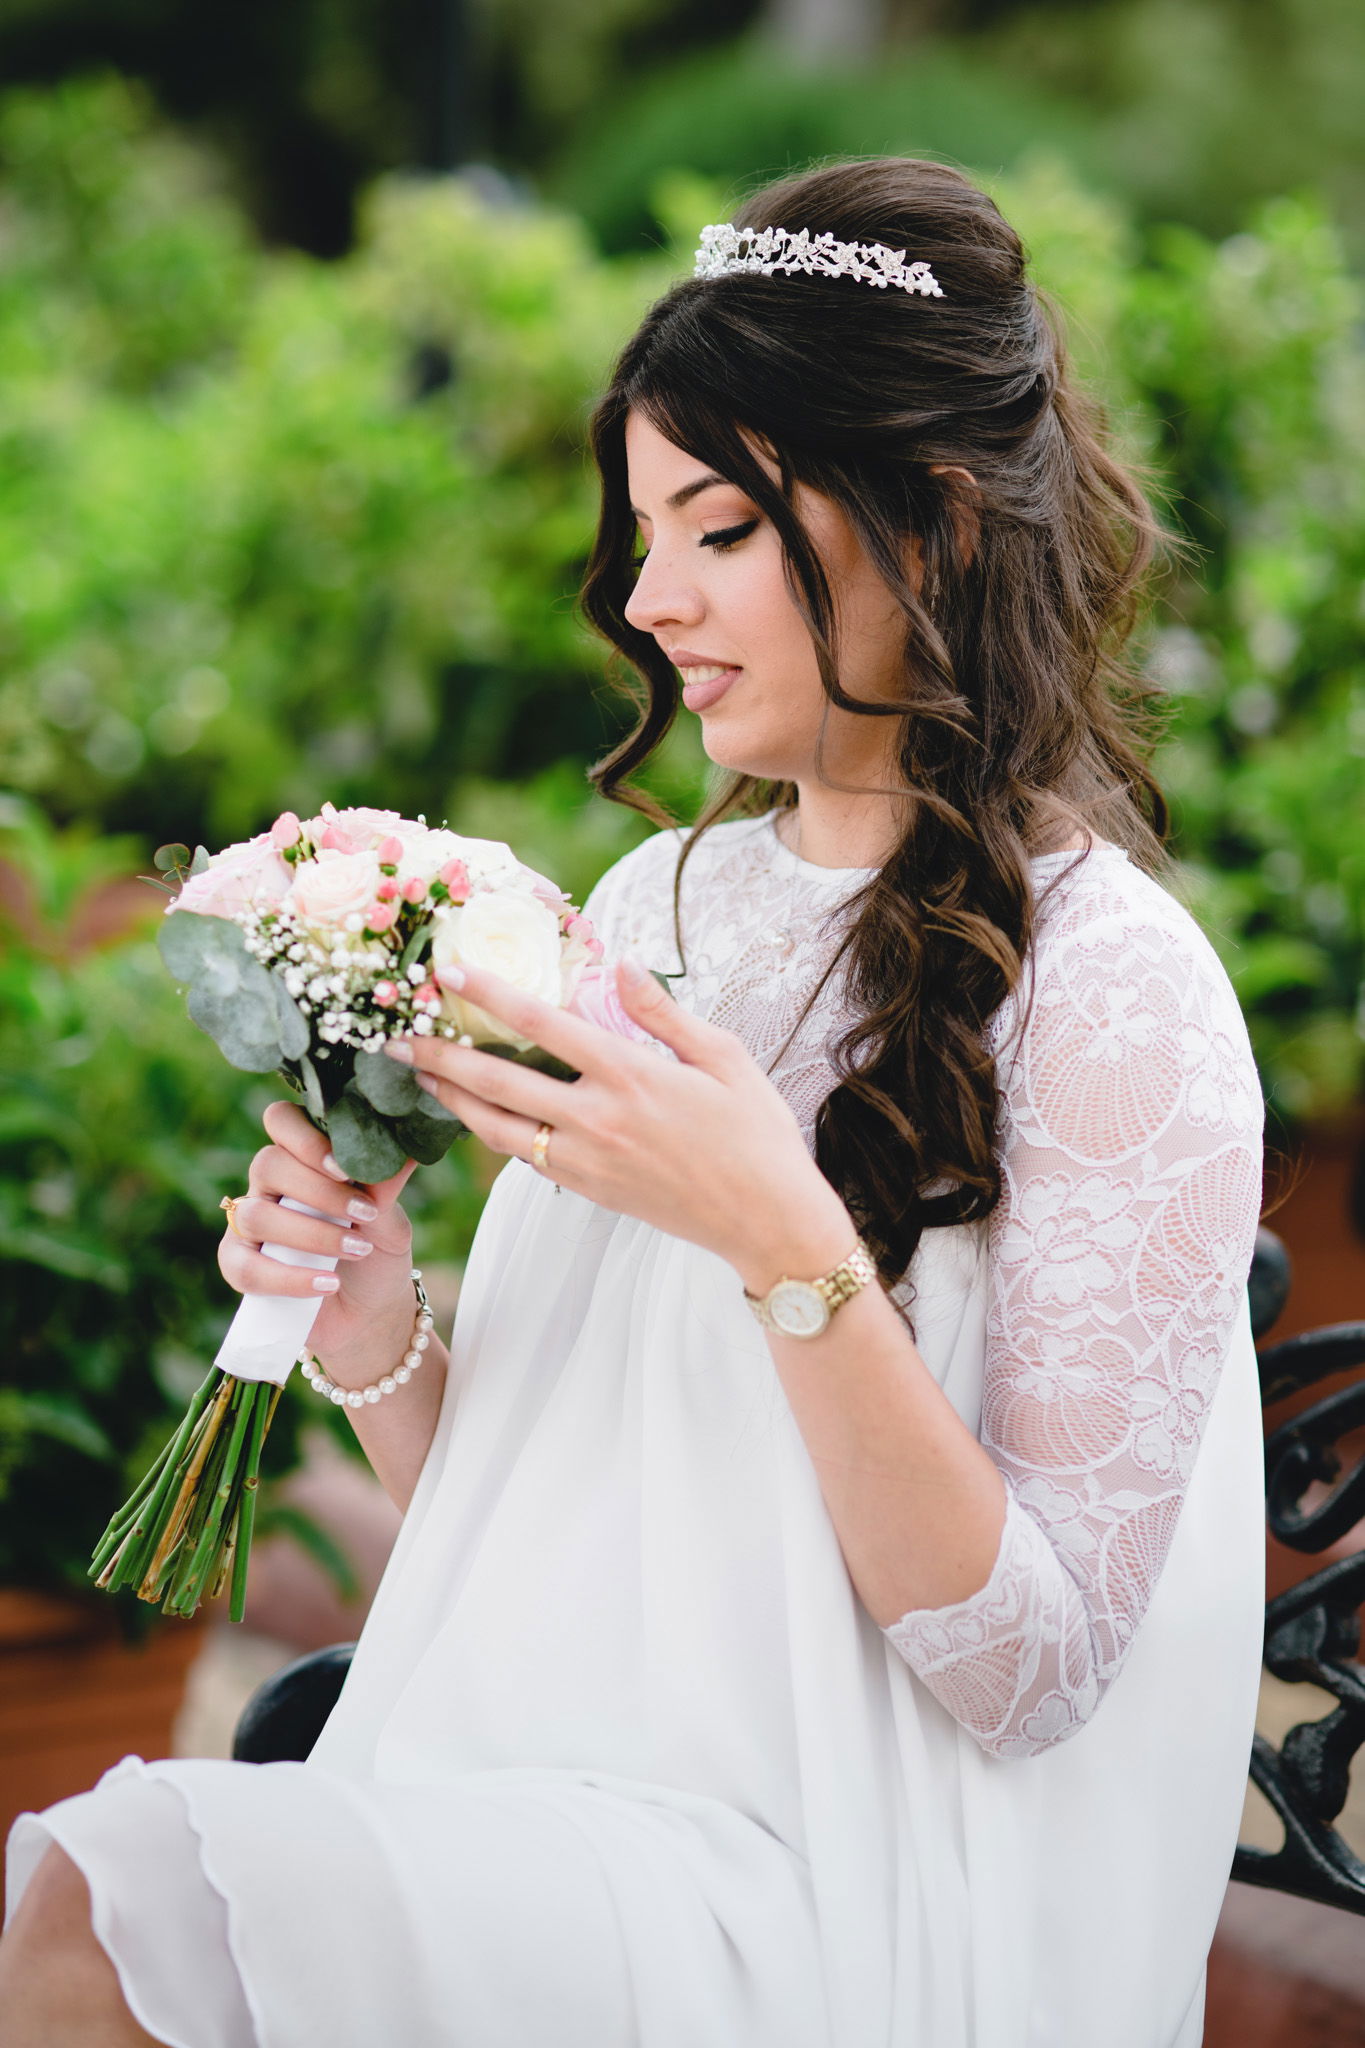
626, 412, 905, 786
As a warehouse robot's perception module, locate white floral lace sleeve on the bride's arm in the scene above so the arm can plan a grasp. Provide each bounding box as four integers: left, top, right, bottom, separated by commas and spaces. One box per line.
886, 858, 1263, 1757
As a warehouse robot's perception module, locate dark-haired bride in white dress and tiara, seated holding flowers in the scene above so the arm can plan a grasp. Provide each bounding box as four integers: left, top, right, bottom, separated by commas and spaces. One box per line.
0, 160, 1263, 2048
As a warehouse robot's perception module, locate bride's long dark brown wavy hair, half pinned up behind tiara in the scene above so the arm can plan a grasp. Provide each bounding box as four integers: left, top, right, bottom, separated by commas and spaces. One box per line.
583, 158, 1166, 1284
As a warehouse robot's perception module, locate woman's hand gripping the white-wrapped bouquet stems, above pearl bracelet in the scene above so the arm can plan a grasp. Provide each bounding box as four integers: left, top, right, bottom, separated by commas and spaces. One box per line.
219, 1102, 415, 1366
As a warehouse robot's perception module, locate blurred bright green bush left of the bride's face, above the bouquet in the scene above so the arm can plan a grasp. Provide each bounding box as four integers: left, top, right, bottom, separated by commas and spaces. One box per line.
0, 82, 683, 844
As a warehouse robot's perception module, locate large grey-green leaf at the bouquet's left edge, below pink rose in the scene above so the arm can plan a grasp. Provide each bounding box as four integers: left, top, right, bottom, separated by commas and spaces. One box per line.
158, 911, 309, 1073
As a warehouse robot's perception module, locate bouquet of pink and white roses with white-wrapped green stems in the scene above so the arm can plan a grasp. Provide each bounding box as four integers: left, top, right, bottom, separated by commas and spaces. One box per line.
90, 803, 643, 1622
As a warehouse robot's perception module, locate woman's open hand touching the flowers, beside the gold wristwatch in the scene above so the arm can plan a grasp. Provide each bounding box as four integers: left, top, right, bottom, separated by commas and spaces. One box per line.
387, 963, 853, 1292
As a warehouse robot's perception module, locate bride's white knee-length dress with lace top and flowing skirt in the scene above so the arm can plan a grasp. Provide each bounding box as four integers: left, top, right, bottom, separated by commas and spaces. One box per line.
6, 813, 1263, 2048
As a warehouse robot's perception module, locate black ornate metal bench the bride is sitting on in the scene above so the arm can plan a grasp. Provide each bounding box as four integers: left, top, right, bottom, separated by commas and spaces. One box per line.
233, 1231, 1365, 1913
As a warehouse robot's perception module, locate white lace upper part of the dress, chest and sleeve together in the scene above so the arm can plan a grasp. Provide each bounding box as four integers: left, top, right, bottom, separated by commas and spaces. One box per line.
585, 813, 1263, 1757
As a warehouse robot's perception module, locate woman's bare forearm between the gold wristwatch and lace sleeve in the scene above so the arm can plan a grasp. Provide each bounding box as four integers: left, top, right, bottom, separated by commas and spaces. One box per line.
737, 1190, 1005, 1628
